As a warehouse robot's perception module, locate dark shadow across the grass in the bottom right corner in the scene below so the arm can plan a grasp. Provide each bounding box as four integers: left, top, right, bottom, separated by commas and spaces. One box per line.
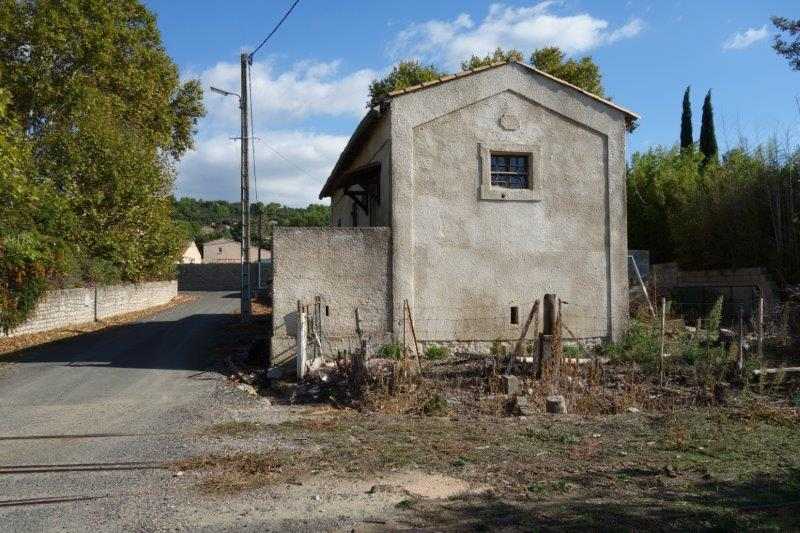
406, 469, 800, 531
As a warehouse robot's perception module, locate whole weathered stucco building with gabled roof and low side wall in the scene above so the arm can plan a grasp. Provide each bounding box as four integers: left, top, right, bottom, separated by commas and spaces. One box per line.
272, 62, 637, 361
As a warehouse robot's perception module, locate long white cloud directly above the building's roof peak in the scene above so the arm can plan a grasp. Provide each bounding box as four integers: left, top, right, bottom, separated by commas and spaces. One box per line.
389, 1, 644, 70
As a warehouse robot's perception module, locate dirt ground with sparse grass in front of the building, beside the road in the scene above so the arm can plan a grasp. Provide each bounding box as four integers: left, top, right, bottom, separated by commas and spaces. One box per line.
173, 334, 800, 531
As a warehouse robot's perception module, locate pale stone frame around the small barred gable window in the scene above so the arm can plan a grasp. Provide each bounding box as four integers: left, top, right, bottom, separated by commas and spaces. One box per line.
478, 143, 541, 202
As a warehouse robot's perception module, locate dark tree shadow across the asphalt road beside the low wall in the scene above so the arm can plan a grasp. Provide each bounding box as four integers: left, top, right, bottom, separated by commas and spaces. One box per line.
3, 310, 238, 371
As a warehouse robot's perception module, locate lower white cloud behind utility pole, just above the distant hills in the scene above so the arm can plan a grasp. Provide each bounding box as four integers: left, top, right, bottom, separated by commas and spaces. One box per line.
176, 130, 347, 206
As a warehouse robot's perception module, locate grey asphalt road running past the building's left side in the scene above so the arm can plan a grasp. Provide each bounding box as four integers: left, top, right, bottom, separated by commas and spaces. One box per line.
0, 293, 244, 531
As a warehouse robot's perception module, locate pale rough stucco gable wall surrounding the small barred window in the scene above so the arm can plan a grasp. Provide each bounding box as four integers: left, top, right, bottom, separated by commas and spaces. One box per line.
391, 64, 628, 341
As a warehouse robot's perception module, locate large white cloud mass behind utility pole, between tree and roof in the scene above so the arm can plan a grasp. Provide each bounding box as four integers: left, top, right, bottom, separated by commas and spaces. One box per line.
176, 60, 379, 206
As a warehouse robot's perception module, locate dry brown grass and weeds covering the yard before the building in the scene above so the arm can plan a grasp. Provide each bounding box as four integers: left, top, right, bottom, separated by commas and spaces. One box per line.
186, 296, 800, 531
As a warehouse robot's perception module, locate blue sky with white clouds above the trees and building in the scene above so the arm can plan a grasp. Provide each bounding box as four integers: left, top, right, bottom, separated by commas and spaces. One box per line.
145, 0, 800, 205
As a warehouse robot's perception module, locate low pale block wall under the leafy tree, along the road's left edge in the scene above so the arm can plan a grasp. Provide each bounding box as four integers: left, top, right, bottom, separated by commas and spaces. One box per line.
3, 281, 178, 337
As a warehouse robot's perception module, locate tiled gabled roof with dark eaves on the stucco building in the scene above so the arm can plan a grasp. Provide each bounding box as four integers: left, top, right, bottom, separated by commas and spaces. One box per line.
319, 61, 639, 199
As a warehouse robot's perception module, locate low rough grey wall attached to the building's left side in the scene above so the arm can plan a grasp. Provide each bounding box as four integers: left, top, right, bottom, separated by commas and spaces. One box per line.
272, 227, 392, 364
